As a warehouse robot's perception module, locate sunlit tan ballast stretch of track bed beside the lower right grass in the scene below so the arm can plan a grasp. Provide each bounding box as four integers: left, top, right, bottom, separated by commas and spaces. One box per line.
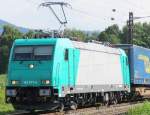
65, 102, 142, 115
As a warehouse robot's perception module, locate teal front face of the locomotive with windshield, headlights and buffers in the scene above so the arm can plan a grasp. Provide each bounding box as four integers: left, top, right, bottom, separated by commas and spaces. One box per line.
6, 40, 55, 101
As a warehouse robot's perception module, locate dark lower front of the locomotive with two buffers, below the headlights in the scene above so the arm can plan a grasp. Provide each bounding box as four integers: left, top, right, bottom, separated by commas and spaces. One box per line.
6, 87, 53, 104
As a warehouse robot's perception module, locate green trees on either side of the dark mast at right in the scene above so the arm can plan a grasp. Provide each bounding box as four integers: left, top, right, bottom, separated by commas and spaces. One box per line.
98, 23, 150, 48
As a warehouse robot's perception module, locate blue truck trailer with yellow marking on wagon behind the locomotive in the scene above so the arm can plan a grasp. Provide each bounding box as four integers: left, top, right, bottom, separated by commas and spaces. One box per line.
115, 44, 150, 98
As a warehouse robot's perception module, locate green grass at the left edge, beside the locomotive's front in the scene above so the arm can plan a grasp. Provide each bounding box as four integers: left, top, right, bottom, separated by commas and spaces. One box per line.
0, 75, 14, 115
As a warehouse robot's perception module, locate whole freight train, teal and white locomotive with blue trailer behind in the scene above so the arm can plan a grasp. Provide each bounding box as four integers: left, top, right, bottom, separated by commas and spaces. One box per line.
6, 38, 150, 110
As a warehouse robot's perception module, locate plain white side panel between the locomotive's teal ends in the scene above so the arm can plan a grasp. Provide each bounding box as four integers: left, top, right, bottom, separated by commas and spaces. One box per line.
77, 50, 123, 85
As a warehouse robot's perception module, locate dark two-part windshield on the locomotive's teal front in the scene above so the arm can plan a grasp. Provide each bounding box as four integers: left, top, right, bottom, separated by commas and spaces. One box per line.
14, 46, 53, 60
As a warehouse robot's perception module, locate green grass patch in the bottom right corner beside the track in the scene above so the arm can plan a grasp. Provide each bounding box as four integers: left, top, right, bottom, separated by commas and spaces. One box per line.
128, 102, 150, 115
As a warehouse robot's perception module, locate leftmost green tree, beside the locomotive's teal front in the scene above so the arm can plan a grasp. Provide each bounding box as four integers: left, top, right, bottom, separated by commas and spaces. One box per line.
0, 25, 23, 73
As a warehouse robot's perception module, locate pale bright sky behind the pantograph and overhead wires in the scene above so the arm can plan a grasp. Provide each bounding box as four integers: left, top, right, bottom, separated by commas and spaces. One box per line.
0, 0, 150, 31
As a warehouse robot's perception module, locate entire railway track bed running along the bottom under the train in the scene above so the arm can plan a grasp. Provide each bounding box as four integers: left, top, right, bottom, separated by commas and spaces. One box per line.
9, 102, 142, 115
